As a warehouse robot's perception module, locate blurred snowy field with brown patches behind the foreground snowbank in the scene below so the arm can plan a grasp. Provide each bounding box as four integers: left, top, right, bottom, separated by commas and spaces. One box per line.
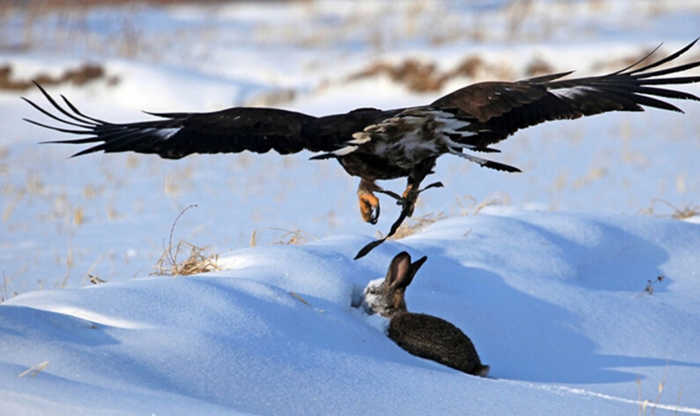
0, 0, 700, 299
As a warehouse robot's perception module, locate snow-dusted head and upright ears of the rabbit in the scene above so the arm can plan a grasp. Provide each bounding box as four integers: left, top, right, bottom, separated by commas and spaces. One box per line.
363, 251, 428, 317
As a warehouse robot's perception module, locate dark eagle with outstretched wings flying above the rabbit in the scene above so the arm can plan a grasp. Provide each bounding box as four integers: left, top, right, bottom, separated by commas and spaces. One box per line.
22, 42, 700, 256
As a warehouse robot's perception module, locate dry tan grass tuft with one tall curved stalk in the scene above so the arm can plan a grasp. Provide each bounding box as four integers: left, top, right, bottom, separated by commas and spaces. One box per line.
153, 204, 220, 276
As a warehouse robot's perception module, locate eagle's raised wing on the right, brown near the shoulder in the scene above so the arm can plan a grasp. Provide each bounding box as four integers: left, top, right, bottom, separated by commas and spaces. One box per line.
431, 39, 700, 148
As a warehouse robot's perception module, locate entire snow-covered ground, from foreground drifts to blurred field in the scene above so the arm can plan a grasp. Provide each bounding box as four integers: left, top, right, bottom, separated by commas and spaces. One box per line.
0, 0, 700, 415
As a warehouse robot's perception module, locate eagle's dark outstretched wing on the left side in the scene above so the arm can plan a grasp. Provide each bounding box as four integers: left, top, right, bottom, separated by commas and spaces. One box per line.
24, 84, 383, 159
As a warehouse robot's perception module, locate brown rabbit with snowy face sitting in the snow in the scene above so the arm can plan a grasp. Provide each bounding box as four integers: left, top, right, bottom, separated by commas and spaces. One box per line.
362, 251, 490, 377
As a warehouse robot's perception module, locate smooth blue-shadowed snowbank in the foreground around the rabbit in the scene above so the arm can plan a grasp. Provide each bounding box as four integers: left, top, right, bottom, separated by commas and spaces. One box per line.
0, 213, 700, 415
